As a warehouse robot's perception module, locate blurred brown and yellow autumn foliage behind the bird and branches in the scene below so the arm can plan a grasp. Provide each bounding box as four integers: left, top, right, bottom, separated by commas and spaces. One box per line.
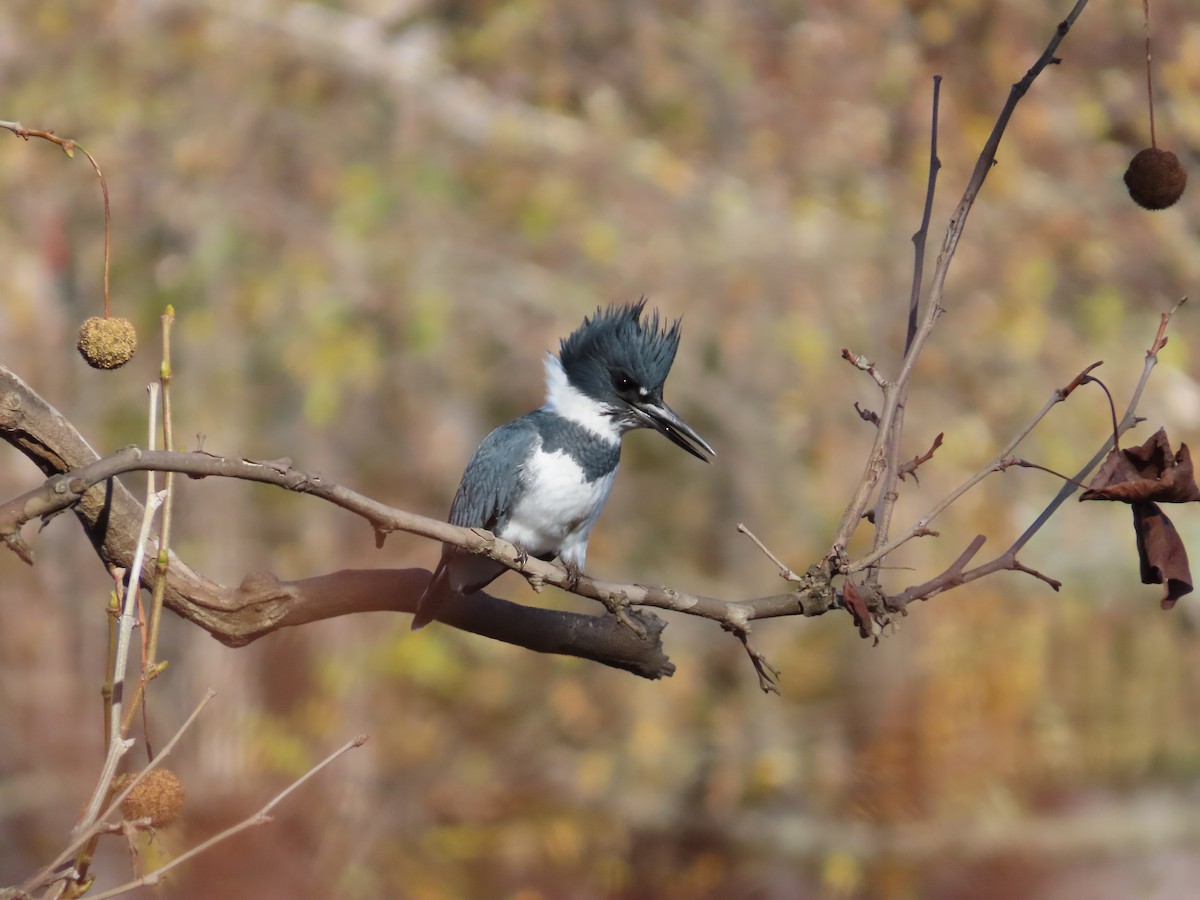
0, 0, 1200, 900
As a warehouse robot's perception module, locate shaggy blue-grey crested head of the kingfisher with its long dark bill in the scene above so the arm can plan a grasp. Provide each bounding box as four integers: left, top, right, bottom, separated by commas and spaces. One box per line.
558, 298, 716, 462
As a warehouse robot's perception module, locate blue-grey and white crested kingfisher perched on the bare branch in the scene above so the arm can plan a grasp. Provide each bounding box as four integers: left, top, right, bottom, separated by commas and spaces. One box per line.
413, 298, 716, 630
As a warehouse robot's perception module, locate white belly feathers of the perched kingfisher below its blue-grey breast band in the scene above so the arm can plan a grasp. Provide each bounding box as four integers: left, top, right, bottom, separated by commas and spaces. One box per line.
499, 450, 617, 566
